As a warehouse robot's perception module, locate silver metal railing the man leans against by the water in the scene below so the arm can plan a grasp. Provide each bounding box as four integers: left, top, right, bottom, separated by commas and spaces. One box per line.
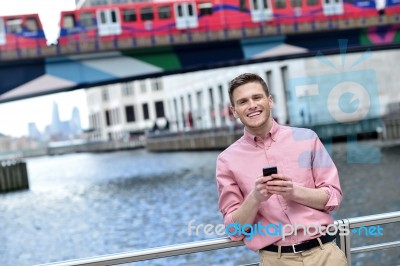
37, 211, 400, 266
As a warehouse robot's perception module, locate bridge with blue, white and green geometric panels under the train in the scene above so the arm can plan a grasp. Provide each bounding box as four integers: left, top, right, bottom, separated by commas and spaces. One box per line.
0, 14, 400, 103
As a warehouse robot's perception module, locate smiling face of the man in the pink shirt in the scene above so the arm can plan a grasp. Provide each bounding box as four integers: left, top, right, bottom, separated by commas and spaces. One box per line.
231, 82, 273, 134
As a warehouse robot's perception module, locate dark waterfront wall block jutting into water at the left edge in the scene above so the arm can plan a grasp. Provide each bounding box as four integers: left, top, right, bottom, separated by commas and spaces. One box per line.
0, 160, 29, 193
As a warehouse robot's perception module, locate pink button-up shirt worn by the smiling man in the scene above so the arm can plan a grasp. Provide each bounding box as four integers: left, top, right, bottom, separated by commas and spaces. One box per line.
216, 121, 342, 250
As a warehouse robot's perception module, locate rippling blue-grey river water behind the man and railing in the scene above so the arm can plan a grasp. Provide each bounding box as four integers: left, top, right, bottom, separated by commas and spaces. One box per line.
0, 144, 400, 266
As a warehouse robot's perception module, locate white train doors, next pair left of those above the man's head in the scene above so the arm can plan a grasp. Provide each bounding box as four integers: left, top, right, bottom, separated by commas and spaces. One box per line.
175, 2, 198, 30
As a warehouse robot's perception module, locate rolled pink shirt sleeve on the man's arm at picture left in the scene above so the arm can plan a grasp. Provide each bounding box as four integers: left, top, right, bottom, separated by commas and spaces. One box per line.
216, 156, 244, 241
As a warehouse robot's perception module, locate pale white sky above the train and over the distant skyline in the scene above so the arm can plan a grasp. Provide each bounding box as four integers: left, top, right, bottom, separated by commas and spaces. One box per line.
0, 0, 88, 137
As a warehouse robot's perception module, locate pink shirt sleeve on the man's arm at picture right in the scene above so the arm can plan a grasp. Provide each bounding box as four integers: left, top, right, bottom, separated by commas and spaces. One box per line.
312, 137, 342, 212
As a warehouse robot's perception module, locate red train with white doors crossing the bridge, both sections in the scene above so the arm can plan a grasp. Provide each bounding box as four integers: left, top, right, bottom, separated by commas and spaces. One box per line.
0, 0, 400, 49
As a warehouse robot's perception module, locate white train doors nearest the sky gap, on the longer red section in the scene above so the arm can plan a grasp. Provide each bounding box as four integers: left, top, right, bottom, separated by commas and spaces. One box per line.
96, 9, 122, 36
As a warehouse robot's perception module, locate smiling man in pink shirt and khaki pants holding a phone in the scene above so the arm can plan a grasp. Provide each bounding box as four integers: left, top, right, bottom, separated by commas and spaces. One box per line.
216, 73, 347, 266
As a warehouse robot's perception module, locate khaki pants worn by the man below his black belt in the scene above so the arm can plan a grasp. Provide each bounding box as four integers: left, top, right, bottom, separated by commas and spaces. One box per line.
259, 242, 347, 266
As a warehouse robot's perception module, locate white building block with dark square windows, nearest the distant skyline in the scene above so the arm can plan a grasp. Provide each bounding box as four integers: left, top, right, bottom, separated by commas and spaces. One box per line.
86, 78, 169, 140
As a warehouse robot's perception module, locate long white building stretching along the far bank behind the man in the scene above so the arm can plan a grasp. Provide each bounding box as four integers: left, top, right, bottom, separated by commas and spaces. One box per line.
87, 50, 400, 140
